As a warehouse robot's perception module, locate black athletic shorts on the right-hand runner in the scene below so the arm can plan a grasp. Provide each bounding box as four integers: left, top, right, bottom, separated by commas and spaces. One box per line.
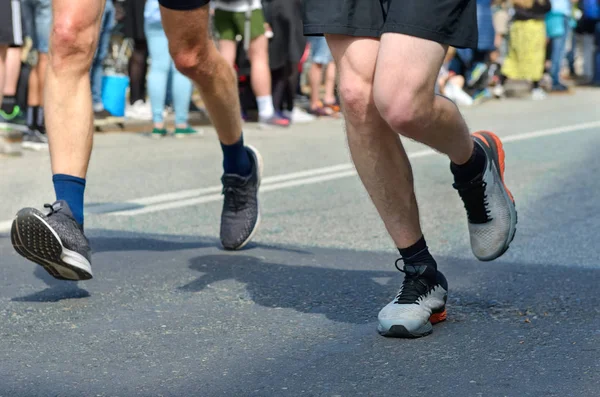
304, 0, 477, 48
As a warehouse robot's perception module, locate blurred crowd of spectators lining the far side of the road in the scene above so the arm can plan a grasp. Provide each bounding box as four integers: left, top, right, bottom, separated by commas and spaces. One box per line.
0, 0, 600, 149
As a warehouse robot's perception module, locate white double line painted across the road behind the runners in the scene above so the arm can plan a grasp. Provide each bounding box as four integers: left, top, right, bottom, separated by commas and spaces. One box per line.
0, 121, 600, 232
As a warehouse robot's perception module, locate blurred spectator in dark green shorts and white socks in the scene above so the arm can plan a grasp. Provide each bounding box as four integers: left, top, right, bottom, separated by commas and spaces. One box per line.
211, 0, 290, 127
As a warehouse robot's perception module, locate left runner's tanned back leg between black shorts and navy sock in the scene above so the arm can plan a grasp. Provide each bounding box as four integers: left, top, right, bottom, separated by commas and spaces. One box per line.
160, 6, 242, 145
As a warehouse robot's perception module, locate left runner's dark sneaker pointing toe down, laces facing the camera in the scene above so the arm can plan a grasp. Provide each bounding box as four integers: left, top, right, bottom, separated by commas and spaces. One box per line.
221, 146, 263, 250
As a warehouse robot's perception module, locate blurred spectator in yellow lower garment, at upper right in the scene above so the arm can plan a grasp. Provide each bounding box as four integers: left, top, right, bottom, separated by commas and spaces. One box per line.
502, 0, 551, 100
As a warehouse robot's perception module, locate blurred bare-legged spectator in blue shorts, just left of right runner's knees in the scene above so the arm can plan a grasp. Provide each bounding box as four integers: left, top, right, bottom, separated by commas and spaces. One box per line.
308, 36, 340, 116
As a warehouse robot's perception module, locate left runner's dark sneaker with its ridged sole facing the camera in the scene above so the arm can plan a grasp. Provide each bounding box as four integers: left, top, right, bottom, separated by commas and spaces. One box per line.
10, 201, 92, 281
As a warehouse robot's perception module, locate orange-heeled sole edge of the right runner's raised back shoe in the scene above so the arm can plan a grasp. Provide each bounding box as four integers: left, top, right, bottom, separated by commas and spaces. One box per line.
473, 131, 519, 262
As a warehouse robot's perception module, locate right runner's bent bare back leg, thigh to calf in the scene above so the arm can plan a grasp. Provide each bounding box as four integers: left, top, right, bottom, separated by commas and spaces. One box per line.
374, 33, 473, 164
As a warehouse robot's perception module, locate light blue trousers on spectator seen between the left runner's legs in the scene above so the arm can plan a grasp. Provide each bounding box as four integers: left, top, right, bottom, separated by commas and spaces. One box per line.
144, 22, 192, 125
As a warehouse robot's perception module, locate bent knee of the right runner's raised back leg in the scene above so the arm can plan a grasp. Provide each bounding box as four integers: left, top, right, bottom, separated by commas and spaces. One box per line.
374, 87, 434, 140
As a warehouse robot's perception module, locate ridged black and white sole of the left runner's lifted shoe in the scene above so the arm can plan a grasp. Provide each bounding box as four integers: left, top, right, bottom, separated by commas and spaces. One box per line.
10, 210, 93, 281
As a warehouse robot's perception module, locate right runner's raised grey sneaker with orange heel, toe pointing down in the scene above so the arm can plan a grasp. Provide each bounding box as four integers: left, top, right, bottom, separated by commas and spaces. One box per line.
453, 131, 517, 261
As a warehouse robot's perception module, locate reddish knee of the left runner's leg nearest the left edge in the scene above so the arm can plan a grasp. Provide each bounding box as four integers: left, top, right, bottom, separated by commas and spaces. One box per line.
50, 16, 96, 72
